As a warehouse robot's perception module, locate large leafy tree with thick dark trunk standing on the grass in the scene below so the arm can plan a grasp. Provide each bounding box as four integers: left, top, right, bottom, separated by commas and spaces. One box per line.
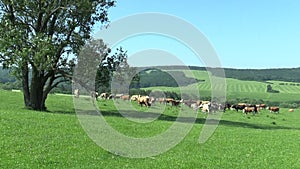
0, 0, 115, 110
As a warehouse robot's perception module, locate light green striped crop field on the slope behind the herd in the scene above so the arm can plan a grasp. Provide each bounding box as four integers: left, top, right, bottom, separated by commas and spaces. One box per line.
144, 70, 300, 102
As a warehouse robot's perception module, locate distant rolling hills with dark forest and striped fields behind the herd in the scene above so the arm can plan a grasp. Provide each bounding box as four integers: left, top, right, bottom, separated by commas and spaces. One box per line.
0, 66, 300, 103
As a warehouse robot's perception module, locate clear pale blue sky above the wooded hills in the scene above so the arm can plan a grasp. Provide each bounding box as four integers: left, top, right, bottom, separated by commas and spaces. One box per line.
92, 0, 300, 68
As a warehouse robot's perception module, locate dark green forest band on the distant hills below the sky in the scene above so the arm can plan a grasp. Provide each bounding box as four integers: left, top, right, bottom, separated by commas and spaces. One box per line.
0, 66, 300, 93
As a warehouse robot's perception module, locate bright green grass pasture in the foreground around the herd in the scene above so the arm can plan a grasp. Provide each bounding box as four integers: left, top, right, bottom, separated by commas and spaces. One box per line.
0, 90, 300, 169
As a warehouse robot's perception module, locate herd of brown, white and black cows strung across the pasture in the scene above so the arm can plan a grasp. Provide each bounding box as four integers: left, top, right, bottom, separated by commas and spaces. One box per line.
85, 92, 288, 114
